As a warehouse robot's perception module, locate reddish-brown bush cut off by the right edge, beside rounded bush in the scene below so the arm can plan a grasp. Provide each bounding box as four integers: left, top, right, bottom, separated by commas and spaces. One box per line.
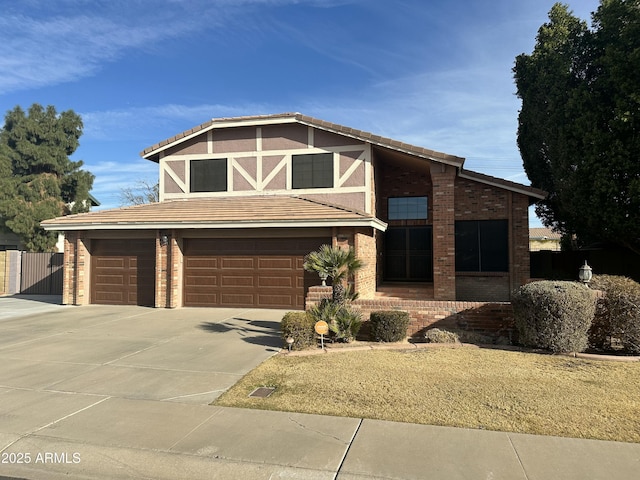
589, 275, 640, 353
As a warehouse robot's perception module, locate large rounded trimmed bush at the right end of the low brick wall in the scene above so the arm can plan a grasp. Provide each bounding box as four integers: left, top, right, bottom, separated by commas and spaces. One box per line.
511, 281, 595, 353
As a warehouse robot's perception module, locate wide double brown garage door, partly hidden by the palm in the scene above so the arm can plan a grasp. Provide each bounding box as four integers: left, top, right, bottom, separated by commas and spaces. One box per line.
184, 238, 331, 309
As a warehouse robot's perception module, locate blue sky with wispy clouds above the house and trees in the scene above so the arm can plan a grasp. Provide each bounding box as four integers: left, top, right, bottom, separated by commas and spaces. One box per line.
0, 0, 598, 226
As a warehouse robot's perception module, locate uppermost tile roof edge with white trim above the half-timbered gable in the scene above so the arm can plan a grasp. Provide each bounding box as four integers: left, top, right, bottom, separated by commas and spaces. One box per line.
140, 113, 464, 167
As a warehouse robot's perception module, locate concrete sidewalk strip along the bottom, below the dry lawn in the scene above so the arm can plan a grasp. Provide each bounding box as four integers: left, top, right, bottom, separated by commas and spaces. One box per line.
0, 404, 640, 480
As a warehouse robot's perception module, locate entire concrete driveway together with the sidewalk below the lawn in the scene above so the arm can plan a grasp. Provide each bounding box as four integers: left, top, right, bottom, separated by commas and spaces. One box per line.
0, 299, 640, 480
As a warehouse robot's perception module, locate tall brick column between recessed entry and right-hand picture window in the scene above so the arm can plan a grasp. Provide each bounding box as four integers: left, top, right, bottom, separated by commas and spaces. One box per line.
431, 163, 456, 300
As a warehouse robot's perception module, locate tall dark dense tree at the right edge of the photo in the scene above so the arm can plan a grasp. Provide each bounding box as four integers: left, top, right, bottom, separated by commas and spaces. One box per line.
514, 0, 640, 254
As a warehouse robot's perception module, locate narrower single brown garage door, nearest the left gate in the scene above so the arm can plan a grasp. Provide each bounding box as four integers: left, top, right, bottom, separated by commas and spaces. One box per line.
91, 239, 155, 306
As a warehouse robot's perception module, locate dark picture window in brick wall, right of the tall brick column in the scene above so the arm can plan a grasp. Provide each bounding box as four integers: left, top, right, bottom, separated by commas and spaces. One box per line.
455, 220, 509, 272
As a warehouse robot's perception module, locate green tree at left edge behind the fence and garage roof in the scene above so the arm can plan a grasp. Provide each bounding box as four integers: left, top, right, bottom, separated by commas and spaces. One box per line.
0, 104, 94, 252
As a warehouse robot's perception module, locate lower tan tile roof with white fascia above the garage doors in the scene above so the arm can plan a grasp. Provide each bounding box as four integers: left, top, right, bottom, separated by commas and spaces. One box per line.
41, 195, 386, 230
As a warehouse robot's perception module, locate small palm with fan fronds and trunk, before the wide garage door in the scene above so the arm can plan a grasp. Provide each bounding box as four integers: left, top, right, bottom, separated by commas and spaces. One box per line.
303, 245, 364, 304
